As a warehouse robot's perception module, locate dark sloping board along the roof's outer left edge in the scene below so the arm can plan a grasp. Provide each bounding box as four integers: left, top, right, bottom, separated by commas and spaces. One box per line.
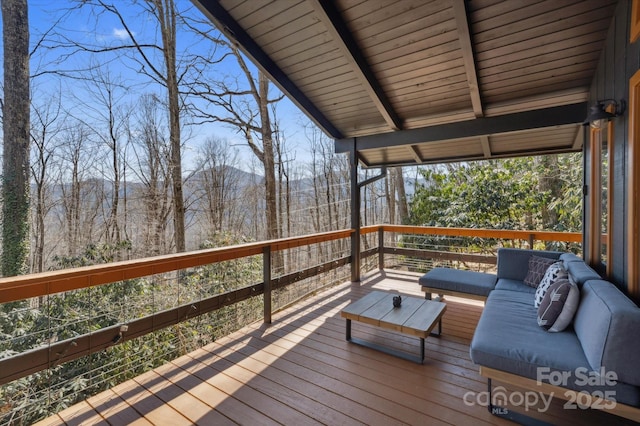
193, 0, 343, 138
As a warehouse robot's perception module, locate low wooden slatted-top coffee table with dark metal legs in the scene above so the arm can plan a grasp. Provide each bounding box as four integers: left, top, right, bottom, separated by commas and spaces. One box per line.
340, 291, 447, 364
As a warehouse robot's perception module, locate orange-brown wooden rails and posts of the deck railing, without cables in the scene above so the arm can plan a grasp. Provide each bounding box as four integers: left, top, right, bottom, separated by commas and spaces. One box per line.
0, 225, 582, 385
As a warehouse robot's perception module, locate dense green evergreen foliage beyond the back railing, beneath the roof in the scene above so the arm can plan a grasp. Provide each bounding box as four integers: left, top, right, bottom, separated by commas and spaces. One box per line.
407, 154, 582, 250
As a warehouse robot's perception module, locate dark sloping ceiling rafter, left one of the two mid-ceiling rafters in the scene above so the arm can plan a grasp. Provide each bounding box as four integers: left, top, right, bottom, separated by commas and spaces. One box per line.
308, 0, 402, 130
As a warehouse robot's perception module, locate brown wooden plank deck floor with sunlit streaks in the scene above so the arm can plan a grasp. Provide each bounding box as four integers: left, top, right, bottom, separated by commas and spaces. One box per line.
40, 271, 636, 425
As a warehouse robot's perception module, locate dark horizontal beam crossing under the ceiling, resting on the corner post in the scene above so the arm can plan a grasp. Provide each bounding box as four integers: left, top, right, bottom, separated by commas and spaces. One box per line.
335, 102, 587, 152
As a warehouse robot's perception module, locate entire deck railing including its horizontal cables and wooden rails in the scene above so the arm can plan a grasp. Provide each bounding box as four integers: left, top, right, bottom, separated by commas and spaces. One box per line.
0, 225, 581, 424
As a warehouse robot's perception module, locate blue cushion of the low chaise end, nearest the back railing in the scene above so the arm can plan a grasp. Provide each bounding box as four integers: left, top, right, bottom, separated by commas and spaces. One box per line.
418, 268, 496, 296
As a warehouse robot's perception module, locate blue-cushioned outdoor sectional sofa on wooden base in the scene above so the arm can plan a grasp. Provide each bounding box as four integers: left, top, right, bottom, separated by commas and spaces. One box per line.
420, 248, 640, 421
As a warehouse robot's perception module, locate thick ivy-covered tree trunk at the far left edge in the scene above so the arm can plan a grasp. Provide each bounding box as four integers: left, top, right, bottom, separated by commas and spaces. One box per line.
2, 0, 30, 276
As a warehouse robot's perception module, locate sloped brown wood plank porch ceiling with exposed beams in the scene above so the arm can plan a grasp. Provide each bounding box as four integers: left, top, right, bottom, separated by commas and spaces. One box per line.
193, 0, 617, 167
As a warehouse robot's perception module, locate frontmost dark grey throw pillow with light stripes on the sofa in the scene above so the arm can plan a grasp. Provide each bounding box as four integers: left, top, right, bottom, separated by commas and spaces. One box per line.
538, 278, 580, 332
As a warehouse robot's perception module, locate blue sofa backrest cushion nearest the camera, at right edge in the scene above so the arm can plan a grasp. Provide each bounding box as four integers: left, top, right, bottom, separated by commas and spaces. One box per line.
573, 280, 640, 386
